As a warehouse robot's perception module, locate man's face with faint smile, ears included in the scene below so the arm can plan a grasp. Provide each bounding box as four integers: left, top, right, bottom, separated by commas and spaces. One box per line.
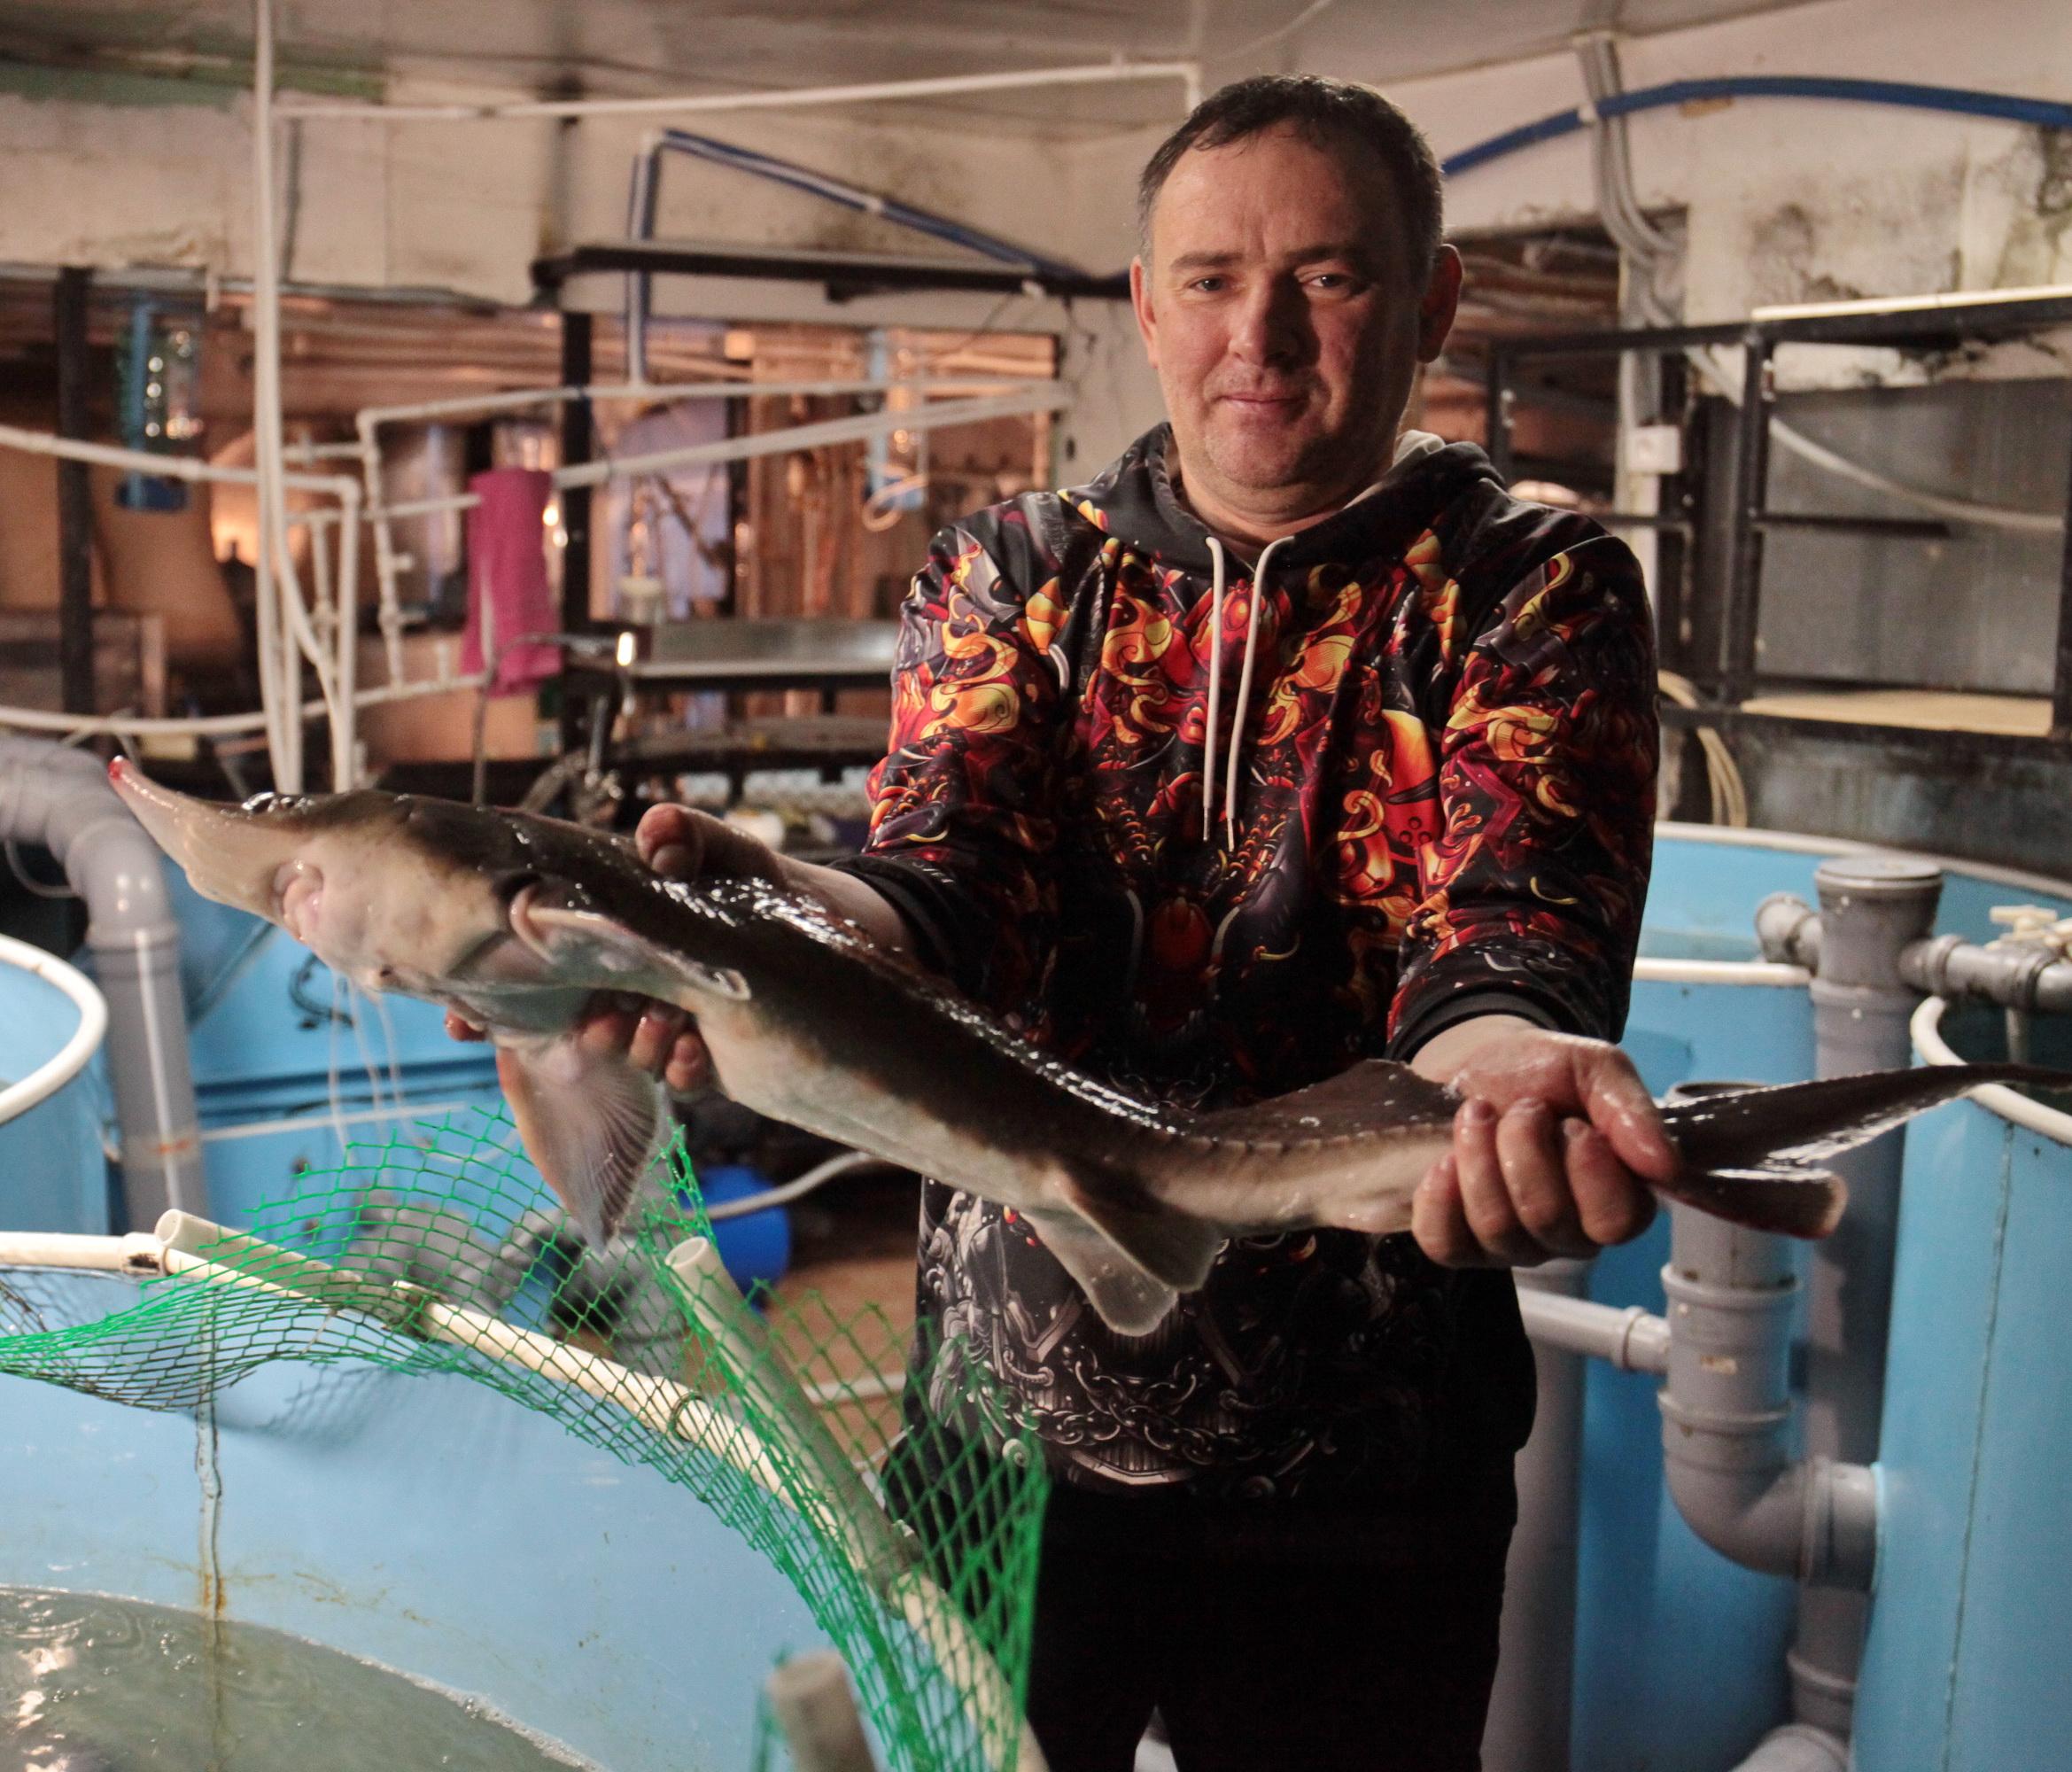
1131, 128, 1461, 518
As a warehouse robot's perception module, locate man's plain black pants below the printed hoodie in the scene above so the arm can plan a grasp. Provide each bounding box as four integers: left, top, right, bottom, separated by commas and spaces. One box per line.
1028, 1472, 1515, 1772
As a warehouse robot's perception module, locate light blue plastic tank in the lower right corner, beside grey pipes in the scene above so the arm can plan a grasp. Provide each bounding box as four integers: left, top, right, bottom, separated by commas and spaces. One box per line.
1857, 1003, 2072, 1772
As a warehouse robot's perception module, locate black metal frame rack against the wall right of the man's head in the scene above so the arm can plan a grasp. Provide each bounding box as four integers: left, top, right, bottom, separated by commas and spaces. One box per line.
1487, 290, 2072, 757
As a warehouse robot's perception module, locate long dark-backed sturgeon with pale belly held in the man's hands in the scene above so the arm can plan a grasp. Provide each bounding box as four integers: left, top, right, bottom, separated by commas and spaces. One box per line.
110, 760, 2072, 1333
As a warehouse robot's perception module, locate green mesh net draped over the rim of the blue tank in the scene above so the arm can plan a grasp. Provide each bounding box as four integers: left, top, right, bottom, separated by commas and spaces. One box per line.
0, 1111, 1046, 1772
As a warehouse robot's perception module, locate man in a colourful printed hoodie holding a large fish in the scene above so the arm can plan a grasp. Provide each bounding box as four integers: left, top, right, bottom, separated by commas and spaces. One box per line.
526, 77, 1670, 1772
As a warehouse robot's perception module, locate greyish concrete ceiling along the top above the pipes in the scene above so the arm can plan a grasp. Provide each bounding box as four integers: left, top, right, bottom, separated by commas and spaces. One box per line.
0, 0, 1803, 133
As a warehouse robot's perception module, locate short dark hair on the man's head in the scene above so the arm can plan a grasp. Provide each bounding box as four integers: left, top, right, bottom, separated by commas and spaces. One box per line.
1137, 74, 1444, 282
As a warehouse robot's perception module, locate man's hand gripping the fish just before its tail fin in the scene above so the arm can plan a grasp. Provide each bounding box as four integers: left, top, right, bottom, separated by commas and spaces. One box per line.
1411, 1015, 1676, 1269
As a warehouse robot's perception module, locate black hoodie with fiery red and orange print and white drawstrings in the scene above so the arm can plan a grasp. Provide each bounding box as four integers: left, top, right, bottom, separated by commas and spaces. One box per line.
833, 427, 1656, 1501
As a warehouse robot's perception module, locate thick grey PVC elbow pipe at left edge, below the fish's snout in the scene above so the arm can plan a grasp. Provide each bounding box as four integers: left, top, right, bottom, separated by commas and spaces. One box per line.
0, 735, 207, 1224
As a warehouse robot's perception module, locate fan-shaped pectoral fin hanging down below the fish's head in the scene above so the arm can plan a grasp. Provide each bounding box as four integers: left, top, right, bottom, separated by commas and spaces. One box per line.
497, 1034, 669, 1246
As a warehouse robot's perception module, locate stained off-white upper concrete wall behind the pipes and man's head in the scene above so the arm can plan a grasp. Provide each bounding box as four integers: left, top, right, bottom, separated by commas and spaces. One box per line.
0, 0, 2072, 472
